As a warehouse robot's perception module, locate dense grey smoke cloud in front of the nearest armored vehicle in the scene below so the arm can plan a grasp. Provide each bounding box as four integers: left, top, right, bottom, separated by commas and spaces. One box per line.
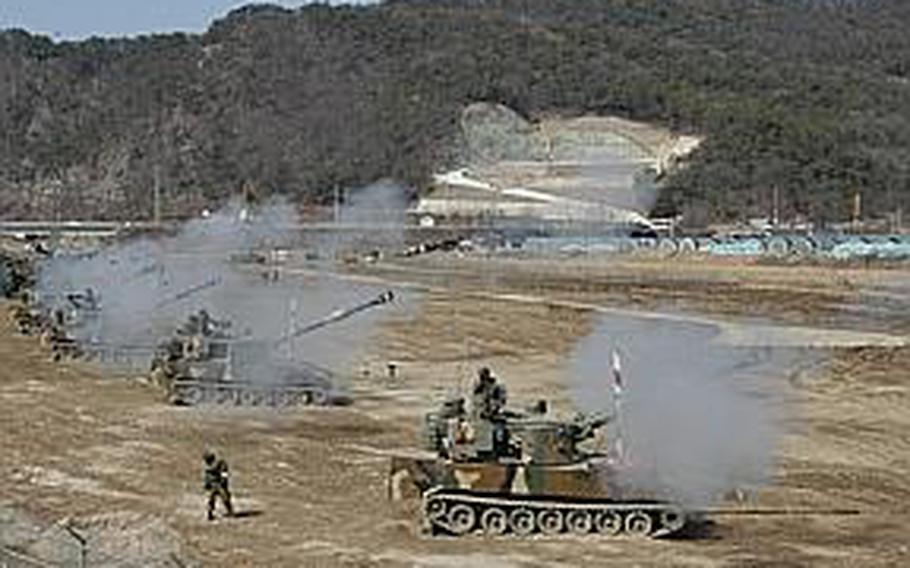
570, 317, 798, 506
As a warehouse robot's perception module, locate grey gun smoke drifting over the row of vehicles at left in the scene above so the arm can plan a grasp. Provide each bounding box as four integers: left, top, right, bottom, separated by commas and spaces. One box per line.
38, 184, 403, 380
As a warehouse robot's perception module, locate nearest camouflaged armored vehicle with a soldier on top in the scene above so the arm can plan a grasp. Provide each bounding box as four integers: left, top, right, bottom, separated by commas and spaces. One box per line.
389, 370, 686, 537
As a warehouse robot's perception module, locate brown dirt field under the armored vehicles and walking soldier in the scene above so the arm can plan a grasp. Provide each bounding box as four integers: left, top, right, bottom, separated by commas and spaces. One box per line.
0, 256, 910, 567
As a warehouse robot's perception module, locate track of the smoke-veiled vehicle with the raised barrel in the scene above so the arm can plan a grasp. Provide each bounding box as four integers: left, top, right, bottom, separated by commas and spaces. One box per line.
170, 381, 339, 407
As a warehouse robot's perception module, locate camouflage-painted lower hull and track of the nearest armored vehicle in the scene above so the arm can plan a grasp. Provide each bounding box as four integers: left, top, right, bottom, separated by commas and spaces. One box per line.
390, 457, 686, 538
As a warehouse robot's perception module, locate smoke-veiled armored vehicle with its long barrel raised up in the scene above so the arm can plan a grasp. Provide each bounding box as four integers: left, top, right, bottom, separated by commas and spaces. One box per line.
151, 292, 393, 406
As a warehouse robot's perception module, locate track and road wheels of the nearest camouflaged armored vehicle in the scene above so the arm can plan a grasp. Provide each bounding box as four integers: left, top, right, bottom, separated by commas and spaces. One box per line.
423, 488, 686, 538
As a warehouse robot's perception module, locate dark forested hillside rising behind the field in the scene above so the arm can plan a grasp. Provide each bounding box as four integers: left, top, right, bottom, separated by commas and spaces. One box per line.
0, 0, 910, 221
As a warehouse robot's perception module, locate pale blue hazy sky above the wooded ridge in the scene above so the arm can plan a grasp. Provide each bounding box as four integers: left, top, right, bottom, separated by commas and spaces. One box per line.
0, 0, 376, 39
